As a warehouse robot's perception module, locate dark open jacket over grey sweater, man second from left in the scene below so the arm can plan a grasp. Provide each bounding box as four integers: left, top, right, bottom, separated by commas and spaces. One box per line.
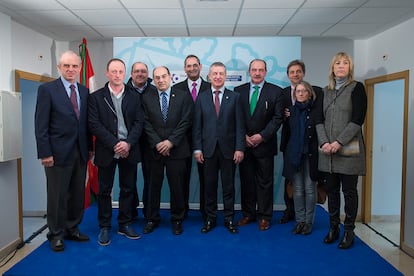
89, 83, 144, 167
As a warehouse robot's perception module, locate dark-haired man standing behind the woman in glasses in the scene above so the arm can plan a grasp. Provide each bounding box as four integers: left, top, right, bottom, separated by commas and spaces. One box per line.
279, 59, 305, 223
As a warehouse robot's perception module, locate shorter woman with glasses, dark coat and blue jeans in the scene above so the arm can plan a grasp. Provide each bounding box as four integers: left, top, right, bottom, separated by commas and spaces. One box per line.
283, 81, 320, 235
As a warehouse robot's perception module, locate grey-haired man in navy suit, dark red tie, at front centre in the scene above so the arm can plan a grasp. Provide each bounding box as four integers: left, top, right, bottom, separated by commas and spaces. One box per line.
193, 62, 245, 233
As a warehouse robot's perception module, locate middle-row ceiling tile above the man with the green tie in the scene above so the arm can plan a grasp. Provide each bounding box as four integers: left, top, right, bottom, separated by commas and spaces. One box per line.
238, 9, 295, 25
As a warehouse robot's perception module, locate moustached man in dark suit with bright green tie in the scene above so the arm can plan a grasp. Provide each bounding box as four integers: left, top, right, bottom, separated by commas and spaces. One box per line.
234, 59, 283, 231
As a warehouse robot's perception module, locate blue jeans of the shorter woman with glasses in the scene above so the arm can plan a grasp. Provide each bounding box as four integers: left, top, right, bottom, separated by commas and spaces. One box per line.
292, 158, 316, 223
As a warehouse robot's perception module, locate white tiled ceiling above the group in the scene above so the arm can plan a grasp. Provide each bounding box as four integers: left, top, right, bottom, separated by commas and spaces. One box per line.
0, 0, 414, 41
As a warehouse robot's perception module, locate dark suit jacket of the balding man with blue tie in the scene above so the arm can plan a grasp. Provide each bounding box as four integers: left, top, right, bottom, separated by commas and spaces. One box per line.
142, 86, 194, 159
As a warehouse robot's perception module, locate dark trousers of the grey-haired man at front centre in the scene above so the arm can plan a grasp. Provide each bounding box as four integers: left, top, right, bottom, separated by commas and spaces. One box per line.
204, 145, 236, 222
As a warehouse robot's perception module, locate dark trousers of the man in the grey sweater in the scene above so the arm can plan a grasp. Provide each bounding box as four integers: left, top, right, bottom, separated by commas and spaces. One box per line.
98, 158, 137, 228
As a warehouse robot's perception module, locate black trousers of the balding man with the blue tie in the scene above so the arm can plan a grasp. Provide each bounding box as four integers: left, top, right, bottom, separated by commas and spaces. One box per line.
145, 157, 186, 223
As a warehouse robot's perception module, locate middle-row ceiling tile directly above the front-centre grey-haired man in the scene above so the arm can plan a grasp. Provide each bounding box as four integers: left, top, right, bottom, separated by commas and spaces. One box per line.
185, 9, 238, 25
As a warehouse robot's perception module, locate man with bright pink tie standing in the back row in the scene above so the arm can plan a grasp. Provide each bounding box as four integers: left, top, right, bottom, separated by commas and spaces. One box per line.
174, 55, 211, 218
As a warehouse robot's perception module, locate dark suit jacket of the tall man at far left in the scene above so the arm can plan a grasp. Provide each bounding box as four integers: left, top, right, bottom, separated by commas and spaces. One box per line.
35, 78, 92, 166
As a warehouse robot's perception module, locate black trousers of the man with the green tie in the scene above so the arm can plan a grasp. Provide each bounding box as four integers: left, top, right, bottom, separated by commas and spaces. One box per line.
239, 150, 274, 221
